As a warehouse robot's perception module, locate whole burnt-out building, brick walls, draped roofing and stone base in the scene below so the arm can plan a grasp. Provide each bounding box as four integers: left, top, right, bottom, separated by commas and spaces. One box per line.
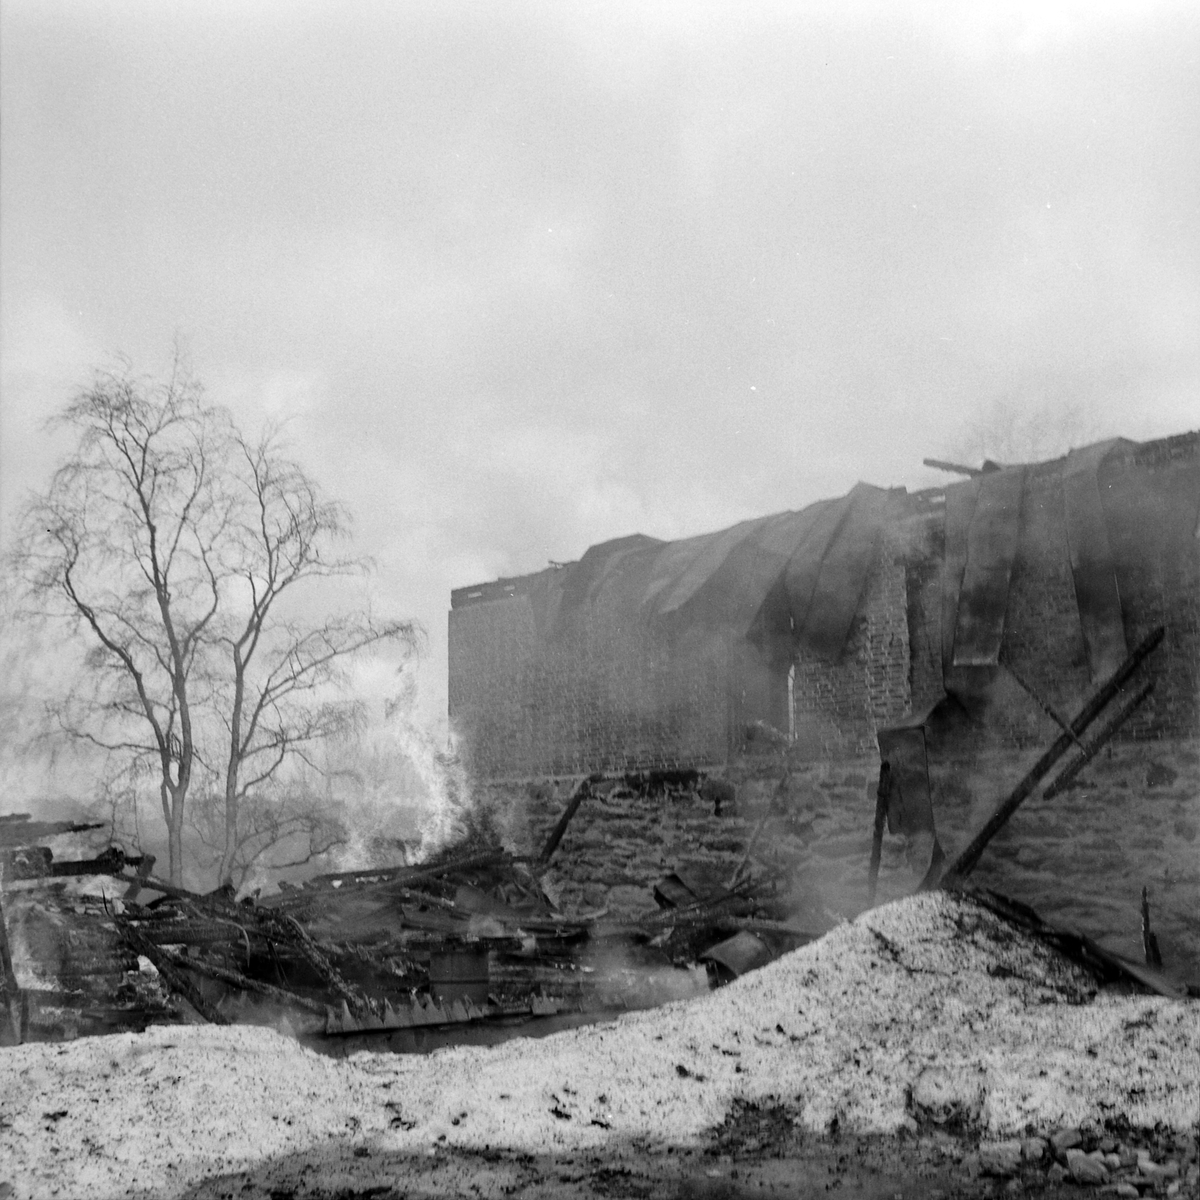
450, 433, 1200, 973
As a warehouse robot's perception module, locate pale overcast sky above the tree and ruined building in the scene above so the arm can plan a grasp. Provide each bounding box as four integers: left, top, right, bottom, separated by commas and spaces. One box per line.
0, 0, 1200, 714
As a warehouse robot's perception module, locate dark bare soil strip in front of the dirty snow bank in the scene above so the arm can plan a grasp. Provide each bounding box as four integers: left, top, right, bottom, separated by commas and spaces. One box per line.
174, 1105, 1200, 1200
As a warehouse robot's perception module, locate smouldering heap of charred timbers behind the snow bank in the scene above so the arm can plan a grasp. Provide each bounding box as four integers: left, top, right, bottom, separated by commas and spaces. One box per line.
0, 806, 814, 1049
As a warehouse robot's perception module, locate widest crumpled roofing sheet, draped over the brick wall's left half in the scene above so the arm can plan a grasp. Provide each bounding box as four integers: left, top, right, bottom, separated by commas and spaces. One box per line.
529, 484, 902, 660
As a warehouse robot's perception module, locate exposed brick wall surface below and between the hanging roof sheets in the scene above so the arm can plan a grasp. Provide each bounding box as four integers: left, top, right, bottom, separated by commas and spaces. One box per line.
450, 434, 1200, 780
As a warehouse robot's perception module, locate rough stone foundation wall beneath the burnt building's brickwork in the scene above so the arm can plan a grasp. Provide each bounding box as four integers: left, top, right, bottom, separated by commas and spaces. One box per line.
485, 740, 1200, 983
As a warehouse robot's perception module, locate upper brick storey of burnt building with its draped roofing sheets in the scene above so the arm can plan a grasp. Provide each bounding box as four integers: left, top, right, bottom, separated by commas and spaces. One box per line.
450, 433, 1200, 781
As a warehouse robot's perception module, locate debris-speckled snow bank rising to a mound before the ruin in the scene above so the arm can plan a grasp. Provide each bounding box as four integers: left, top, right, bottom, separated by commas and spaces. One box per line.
0, 893, 1200, 1200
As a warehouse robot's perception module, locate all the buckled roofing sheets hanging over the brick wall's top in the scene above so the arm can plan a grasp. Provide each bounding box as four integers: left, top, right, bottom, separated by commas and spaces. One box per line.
506, 433, 1200, 679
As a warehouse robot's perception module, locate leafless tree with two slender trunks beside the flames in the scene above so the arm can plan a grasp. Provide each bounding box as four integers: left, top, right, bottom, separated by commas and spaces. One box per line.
13, 361, 416, 883
